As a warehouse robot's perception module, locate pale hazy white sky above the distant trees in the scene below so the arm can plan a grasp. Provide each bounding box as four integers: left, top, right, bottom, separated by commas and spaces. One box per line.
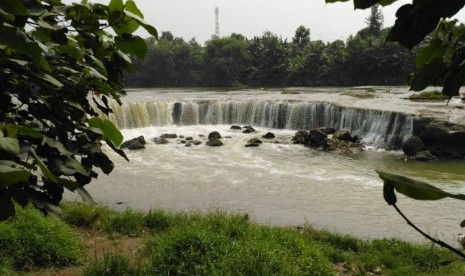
63, 0, 465, 44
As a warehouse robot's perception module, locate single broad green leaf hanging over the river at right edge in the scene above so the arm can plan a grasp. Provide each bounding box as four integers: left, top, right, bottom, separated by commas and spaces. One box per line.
376, 170, 465, 200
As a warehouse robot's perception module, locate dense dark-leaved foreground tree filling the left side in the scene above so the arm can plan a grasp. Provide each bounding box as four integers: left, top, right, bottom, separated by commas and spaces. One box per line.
0, 0, 157, 220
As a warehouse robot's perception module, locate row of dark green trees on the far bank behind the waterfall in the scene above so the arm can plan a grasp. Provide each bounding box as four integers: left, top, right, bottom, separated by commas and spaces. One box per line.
127, 7, 414, 87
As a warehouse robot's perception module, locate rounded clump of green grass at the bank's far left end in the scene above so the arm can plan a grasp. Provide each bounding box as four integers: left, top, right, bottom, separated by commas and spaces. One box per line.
0, 208, 83, 271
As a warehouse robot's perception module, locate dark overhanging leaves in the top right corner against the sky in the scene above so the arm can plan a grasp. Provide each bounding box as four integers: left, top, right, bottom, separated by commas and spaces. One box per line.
326, 0, 465, 98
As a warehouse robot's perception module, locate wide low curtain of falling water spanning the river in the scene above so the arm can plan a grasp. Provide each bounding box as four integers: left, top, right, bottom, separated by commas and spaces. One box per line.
104, 99, 413, 149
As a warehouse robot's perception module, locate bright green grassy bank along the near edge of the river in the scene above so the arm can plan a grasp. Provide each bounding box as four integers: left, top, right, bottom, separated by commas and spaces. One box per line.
0, 203, 465, 275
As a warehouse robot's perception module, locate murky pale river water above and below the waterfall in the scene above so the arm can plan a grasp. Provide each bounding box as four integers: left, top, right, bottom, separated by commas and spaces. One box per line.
69, 88, 465, 245
